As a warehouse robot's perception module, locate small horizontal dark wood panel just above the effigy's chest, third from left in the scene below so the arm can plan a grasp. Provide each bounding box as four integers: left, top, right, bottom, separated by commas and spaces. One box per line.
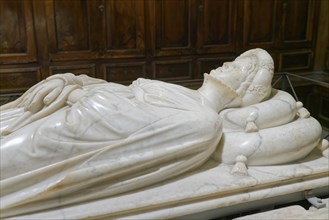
102, 62, 146, 84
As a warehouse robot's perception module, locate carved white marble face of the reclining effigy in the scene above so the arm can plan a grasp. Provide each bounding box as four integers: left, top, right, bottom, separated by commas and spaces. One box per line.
210, 56, 257, 91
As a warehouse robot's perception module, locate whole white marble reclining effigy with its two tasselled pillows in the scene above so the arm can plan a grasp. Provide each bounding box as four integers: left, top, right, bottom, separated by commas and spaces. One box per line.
1, 49, 328, 217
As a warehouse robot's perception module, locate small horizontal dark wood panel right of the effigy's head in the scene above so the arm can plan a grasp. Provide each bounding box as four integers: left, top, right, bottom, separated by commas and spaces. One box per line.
280, 51, 313, 71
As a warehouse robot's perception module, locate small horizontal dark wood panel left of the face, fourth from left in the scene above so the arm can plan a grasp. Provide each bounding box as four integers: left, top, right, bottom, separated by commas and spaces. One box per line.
153, 59, 192, 81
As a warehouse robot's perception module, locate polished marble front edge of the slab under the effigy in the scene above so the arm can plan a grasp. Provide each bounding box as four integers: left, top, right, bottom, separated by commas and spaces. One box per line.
120, 176, 329, 220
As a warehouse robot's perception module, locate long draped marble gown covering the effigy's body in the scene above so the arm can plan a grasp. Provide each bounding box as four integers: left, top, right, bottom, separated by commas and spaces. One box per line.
1, 79, 222, 213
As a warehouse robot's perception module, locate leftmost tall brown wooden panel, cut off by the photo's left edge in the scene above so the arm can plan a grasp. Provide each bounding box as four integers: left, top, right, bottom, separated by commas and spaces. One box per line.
0, 0, 37, 64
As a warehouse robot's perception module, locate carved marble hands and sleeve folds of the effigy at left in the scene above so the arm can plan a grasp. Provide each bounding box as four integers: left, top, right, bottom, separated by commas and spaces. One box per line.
0, 73, 105, 135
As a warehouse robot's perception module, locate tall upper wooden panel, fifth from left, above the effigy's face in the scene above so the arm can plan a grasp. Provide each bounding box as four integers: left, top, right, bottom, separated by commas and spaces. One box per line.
196, 0, 237, 54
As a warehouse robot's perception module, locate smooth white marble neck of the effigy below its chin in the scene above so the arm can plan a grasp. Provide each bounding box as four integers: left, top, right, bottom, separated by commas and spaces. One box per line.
198, 73, 240, 112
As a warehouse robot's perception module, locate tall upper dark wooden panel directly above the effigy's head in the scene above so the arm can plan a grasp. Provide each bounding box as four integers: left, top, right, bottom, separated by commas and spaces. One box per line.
240, 0, 278, 50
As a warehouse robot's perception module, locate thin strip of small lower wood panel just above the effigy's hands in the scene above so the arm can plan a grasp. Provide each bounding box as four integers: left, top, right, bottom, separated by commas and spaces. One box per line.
49, 64, 96, 77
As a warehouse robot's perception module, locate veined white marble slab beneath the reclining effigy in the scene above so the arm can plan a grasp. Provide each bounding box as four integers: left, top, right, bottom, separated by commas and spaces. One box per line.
1, 149, 329, 219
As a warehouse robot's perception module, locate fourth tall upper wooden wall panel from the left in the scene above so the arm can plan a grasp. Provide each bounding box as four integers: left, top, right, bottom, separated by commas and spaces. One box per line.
149, 0, 196, 56
